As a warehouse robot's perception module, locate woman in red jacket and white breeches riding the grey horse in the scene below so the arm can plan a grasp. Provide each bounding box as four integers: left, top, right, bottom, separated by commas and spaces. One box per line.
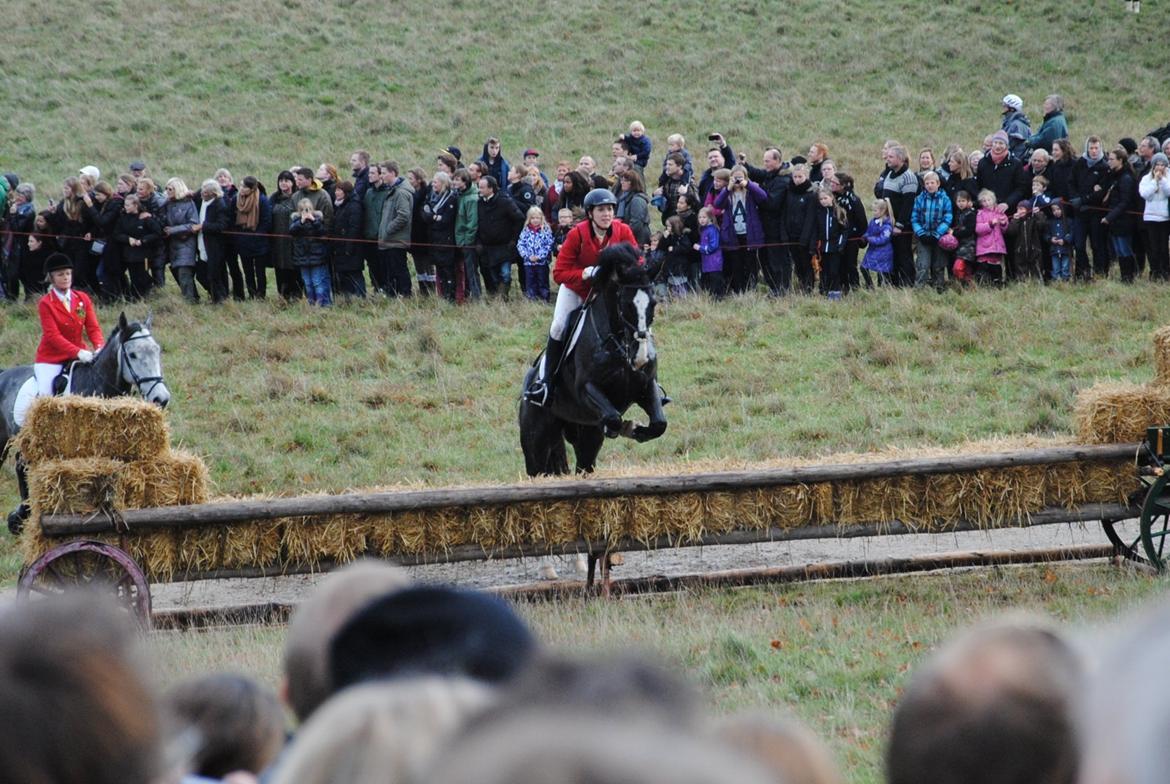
33, 253, 105, 396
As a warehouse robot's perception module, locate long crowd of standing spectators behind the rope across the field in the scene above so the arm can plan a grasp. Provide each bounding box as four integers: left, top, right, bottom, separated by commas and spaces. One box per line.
0, 95, 1170, 305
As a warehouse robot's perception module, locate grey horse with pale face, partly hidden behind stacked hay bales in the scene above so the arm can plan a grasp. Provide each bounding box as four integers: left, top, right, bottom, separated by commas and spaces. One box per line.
0, 314, 171, 534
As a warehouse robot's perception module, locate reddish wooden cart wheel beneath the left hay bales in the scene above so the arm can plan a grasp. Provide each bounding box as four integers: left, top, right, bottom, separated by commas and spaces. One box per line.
16, 541, 151, 626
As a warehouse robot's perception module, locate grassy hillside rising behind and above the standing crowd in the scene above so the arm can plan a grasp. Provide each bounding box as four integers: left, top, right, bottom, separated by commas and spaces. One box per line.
0, 0, 1168, 192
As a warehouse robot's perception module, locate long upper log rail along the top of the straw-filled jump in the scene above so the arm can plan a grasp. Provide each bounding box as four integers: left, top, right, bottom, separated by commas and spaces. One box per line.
41, 443, 1137, 538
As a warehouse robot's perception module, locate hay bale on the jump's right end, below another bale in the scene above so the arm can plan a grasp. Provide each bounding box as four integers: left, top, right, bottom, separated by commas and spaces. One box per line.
1073, 383, 1170, 443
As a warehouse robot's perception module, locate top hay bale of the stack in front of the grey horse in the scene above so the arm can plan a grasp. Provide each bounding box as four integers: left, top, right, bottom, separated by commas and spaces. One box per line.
15, 394, 171, 463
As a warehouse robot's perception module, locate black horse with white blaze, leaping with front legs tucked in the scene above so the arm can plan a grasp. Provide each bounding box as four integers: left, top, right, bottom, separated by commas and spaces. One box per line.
519, 245, 666, 476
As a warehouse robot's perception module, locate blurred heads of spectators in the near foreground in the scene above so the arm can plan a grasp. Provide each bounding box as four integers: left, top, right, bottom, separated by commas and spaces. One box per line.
0, 562, 1170, 784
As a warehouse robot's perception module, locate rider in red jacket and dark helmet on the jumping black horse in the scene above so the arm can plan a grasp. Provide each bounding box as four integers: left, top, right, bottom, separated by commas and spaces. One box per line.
524, 188, 638, 406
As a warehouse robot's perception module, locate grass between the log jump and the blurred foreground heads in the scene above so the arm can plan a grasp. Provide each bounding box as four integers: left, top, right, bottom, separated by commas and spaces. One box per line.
152, 566, 1165, 784
